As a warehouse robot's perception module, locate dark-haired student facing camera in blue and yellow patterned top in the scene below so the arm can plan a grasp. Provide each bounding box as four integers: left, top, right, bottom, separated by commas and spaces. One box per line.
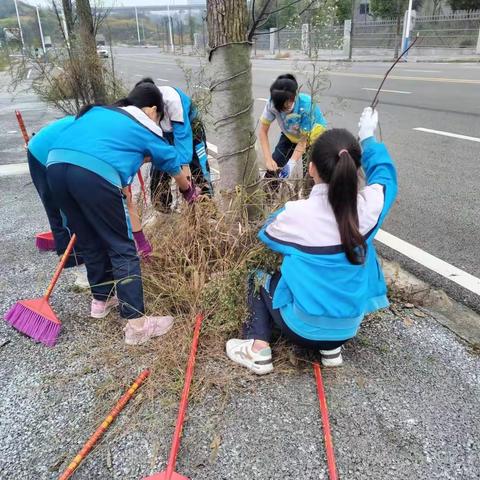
258, 73, 327, 185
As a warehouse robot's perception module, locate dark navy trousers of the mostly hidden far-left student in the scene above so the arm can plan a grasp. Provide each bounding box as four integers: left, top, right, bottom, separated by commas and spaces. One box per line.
27, 150, 83, 268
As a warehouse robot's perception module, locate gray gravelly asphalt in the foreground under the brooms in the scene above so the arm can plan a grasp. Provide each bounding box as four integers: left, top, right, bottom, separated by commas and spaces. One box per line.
0, 171, 480, 480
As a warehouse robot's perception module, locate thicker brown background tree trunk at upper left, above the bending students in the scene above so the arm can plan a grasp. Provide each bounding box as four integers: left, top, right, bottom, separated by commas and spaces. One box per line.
76, 0, 106, 103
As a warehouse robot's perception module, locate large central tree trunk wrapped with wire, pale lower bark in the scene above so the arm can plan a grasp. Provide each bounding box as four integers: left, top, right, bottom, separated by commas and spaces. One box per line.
207, 0, 259, 192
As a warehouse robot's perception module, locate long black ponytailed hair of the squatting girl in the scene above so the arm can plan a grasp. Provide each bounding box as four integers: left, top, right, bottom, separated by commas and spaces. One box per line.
310, 128, 366, 265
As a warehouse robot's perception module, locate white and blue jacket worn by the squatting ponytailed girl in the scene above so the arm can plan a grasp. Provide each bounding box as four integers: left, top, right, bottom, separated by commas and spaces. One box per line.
259, 137, 398, 340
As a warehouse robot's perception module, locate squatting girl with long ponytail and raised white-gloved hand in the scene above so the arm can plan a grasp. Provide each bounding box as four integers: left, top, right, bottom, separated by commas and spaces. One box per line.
226, 107, 397, 375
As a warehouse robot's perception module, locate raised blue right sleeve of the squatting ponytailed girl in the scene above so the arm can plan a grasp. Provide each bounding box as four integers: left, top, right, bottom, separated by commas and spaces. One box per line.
362, 137, 398, 221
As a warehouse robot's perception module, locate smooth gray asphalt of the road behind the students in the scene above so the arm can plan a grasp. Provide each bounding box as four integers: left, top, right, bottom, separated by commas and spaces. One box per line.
109, 48, 480, 311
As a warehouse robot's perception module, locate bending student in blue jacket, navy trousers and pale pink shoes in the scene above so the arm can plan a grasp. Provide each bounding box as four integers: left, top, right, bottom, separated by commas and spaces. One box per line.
47, 84, 197, 345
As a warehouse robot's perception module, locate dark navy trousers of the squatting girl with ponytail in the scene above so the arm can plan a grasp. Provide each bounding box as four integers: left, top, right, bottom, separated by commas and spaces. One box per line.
243, 272, 350, 350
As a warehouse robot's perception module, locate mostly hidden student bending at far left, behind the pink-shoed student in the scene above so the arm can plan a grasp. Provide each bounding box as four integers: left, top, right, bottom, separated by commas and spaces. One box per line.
27, 115, 88, 288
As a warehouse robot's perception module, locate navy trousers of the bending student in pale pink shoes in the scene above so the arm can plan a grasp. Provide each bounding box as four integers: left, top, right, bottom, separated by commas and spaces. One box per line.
47, 163, 145, 319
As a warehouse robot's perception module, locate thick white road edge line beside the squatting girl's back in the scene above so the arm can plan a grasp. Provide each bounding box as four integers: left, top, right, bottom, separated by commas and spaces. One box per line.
375, 230, 480, 295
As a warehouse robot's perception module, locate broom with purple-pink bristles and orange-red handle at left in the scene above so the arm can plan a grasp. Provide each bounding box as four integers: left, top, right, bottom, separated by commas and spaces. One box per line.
4, 234, 77, 347
